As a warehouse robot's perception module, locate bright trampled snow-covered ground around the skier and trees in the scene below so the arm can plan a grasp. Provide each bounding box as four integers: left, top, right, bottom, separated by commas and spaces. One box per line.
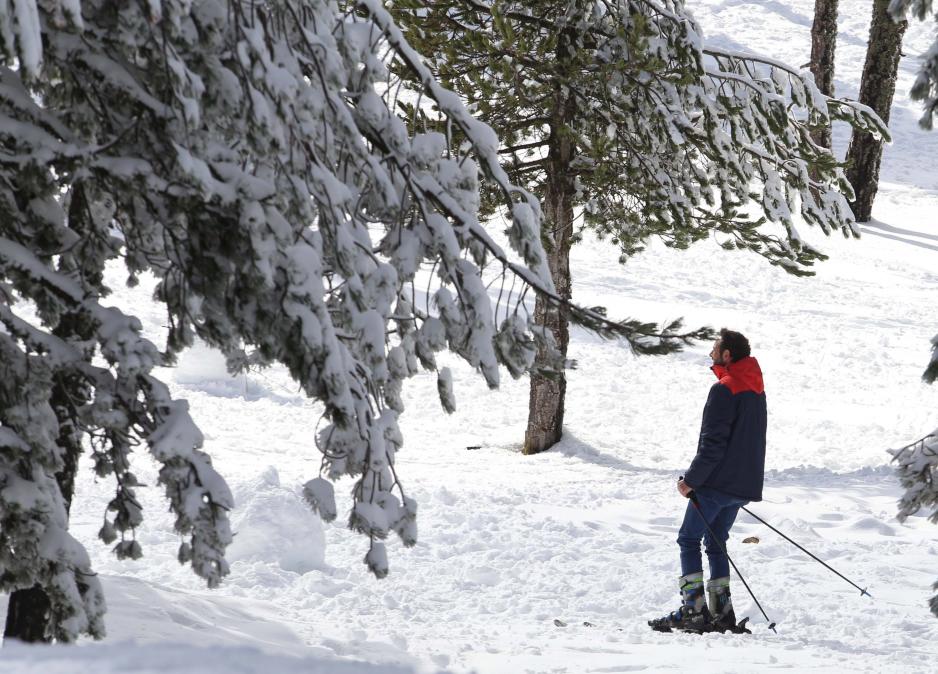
0, 0, 938, 674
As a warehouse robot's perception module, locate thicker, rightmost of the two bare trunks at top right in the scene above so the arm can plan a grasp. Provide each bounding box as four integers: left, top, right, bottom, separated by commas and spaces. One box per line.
846, 0, 908, 222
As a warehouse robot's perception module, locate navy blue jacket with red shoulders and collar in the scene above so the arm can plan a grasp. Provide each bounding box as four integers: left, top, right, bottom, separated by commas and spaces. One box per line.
684, 356, 767, 501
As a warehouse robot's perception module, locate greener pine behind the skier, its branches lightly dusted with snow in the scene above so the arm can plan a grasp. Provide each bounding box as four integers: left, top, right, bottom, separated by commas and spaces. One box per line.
392, 0, 886, 452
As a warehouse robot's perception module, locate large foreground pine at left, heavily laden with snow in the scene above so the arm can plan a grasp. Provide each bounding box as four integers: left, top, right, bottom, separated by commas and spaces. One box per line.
0, 0, 709, 641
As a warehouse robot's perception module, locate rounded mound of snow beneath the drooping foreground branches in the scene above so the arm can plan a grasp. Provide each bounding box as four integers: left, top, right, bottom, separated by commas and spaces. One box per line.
226, 467, 326, 574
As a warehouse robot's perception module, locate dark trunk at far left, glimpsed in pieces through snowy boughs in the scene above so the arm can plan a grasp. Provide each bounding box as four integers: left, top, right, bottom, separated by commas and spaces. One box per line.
3, 188, 93, 643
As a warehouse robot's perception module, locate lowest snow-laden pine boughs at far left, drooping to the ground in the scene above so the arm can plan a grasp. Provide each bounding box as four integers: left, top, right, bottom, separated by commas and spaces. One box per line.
0, 234, 232, 641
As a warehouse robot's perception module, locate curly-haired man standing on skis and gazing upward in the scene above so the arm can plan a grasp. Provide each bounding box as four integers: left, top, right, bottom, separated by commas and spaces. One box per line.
648, 328, 766, 632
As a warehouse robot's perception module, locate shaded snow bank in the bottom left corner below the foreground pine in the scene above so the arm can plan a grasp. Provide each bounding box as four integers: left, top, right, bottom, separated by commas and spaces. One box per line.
0, 576, 412, 674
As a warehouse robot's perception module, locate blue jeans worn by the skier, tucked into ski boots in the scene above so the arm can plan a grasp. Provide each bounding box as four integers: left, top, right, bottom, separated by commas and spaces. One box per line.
677, 487, 749, 578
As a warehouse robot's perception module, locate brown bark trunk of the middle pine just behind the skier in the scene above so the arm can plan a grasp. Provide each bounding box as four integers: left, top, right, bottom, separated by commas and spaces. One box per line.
522, 32, 576, 454
